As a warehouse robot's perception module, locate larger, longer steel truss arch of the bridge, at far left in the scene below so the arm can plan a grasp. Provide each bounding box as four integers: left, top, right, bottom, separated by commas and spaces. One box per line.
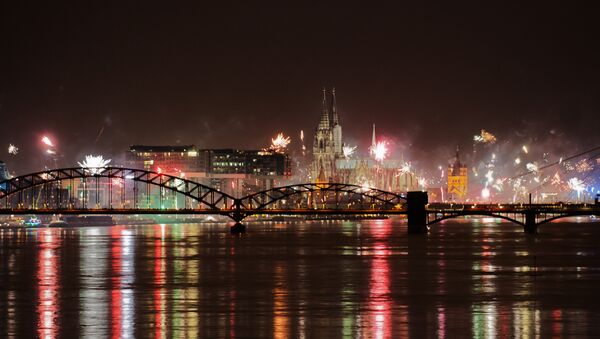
0, 167, 236, 210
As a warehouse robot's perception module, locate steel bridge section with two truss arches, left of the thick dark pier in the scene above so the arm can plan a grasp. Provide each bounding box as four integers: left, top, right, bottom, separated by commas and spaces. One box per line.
0, 167, 406, 221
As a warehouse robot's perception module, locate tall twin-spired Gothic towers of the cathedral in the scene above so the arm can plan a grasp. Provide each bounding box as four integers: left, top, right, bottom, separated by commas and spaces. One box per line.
311, 88, 343, 182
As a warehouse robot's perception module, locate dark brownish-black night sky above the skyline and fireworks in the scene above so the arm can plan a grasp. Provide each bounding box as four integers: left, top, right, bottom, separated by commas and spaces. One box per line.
0, 1, 600, 171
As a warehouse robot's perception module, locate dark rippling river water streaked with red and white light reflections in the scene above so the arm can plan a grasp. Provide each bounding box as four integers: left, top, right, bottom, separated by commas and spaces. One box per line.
0, 218, 600, 338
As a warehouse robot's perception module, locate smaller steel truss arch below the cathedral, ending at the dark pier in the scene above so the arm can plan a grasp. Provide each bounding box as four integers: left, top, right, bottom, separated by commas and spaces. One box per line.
239, 183, 406, 210
